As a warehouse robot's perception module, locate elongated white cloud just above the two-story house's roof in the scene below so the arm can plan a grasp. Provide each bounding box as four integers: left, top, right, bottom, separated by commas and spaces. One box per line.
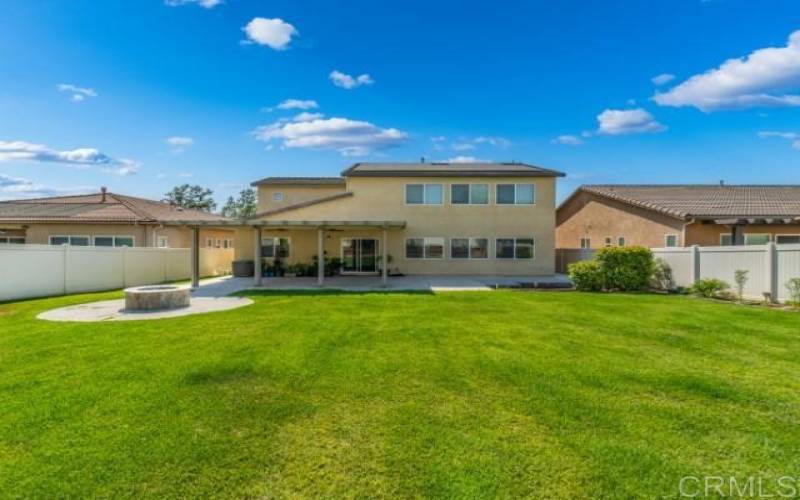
253, 118, 408, 156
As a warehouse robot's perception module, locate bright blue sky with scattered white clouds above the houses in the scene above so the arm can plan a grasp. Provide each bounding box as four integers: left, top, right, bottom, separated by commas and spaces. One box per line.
0, 0, 800, 202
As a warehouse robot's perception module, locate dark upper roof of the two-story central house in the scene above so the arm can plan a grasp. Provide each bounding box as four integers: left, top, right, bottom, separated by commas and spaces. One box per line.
342, 162, 564, 177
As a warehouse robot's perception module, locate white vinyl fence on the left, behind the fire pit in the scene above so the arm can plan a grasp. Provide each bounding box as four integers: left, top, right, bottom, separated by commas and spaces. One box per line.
0, 244, 233, 301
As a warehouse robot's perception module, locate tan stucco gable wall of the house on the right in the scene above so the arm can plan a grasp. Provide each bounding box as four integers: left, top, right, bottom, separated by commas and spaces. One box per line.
556, 193, 684, 248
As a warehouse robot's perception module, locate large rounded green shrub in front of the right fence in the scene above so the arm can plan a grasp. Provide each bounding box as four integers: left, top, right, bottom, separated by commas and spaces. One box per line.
595, 246, 655, 291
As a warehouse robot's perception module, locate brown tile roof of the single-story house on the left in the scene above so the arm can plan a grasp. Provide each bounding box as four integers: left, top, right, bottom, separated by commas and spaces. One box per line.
0, 193, 228, 223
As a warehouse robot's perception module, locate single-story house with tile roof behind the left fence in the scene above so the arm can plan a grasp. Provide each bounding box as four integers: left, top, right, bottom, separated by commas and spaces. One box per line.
0, 188, 234, 248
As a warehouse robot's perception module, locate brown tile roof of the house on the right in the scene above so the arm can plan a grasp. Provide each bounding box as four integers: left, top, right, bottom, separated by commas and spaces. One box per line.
580, 184, 800, 219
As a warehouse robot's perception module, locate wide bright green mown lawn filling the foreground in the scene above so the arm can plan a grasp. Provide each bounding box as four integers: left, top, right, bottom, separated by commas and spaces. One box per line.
0, 291, 800, 498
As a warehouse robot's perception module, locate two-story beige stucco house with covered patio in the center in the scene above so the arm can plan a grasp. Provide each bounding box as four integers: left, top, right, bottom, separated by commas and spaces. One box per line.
236, 163, 563, 276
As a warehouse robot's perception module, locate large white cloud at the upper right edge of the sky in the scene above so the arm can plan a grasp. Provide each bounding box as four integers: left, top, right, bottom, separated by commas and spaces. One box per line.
653, 31, 800, 111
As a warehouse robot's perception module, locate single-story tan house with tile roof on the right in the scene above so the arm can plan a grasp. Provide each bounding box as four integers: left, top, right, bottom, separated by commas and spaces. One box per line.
556, 184, 800, 248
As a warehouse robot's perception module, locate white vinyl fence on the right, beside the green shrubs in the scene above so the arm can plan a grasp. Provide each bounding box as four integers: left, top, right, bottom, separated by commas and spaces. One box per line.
556, 243, 800, 302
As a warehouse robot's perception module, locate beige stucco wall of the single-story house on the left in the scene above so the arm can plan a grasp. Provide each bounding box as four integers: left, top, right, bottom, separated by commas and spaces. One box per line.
10, 224, 234, 248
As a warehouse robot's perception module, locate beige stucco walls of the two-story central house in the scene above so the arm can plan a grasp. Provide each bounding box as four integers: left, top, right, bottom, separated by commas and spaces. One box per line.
241, 177, 555, 275
